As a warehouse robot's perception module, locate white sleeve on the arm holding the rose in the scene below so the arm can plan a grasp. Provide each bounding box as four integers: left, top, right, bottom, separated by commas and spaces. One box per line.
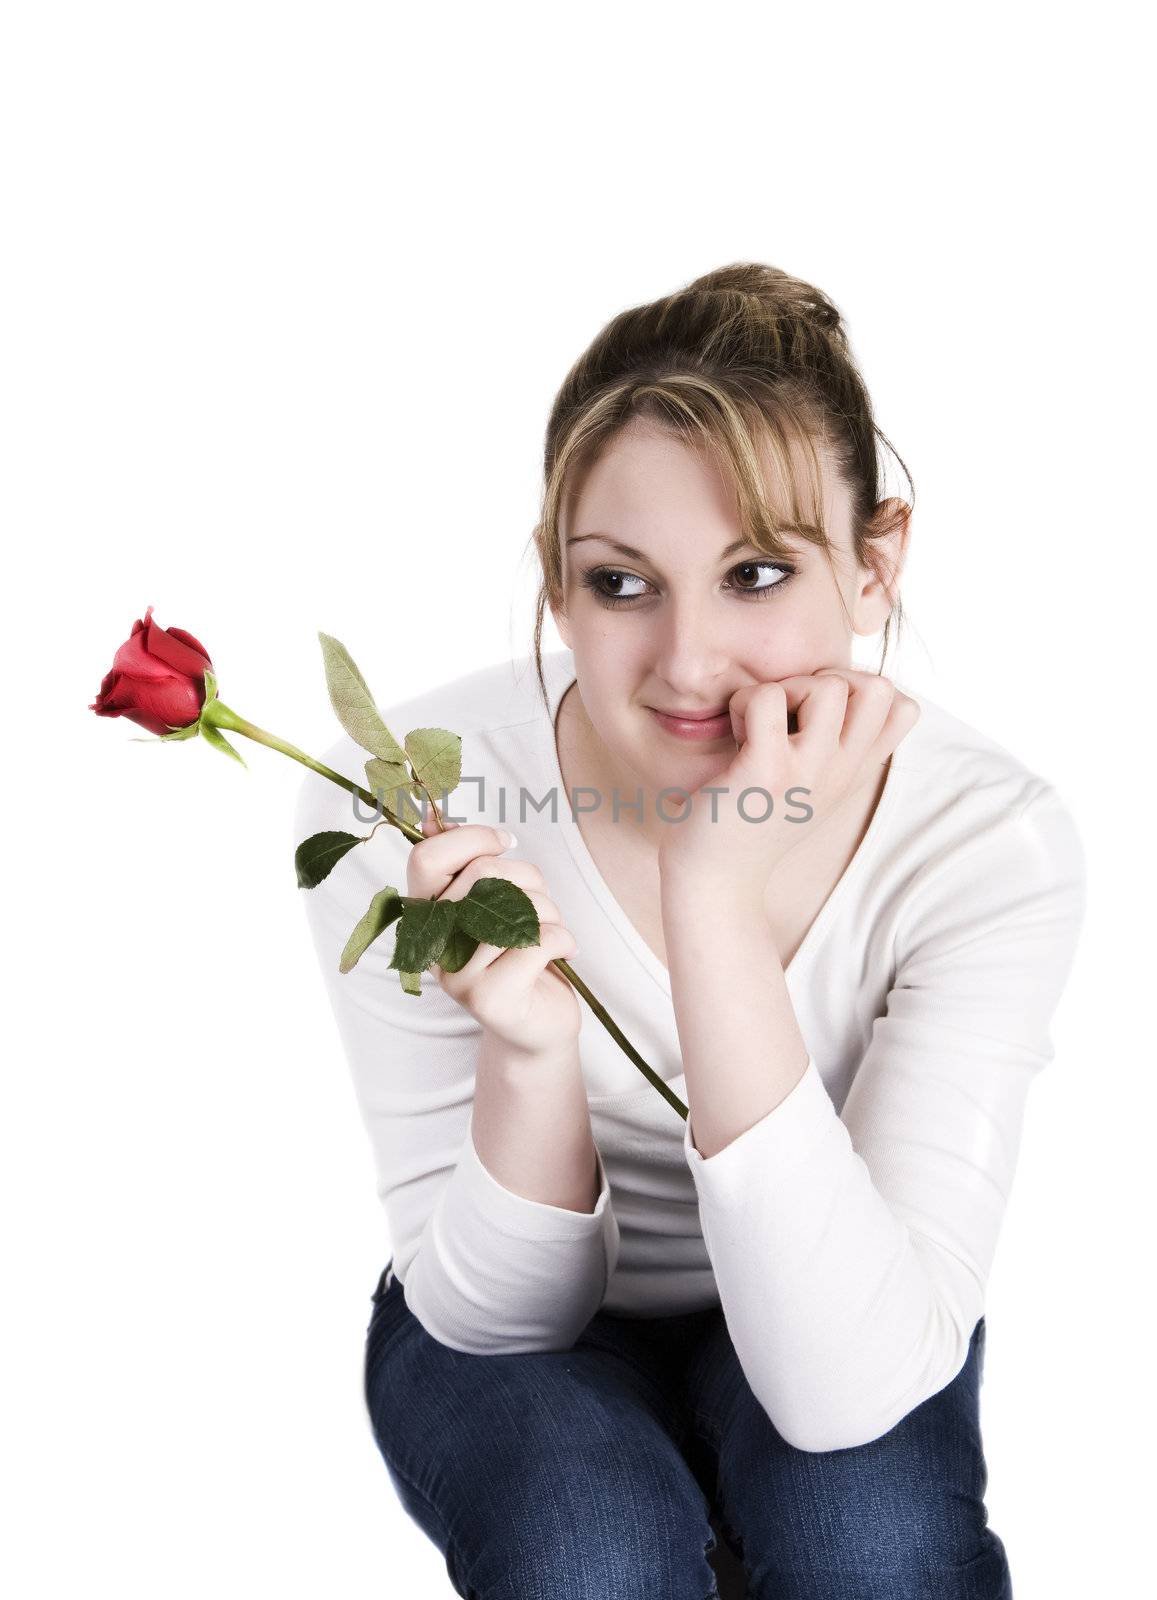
293, 741, 619, 1355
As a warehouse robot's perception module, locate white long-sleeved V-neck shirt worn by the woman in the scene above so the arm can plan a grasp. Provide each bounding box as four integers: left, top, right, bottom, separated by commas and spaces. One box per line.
293, 650, 1085, 1450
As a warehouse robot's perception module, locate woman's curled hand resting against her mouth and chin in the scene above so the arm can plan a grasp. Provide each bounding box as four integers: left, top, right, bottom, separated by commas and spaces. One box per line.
659, 667, 920, 906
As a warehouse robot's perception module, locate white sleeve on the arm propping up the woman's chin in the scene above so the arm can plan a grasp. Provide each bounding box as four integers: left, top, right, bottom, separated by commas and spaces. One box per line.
683, 784, 1085, 1451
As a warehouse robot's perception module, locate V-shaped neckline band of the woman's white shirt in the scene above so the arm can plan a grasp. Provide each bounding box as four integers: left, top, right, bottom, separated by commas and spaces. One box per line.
534, 650, 923, 998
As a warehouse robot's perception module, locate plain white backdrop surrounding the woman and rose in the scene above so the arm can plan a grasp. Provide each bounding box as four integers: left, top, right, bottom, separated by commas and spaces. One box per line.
0, 0, 1155, 1600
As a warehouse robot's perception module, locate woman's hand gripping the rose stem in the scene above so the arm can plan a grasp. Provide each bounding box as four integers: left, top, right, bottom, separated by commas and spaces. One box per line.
406, 810, 583, 1056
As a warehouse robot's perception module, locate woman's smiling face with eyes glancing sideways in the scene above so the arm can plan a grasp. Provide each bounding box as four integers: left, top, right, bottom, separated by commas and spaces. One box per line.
552, 421, 907, 834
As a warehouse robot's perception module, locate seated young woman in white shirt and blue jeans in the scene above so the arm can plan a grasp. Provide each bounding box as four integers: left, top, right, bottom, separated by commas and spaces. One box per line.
294, 264, 1083, 1600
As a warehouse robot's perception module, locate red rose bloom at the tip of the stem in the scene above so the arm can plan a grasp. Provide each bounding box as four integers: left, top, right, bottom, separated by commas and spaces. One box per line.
88, 606, 213, 734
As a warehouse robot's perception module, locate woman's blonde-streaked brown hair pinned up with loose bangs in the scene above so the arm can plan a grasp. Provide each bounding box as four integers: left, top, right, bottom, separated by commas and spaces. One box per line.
531, 261, 915, 702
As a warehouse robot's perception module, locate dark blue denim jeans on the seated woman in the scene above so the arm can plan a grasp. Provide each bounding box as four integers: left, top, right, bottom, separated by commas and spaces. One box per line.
365, 1262, 1011, 1600
